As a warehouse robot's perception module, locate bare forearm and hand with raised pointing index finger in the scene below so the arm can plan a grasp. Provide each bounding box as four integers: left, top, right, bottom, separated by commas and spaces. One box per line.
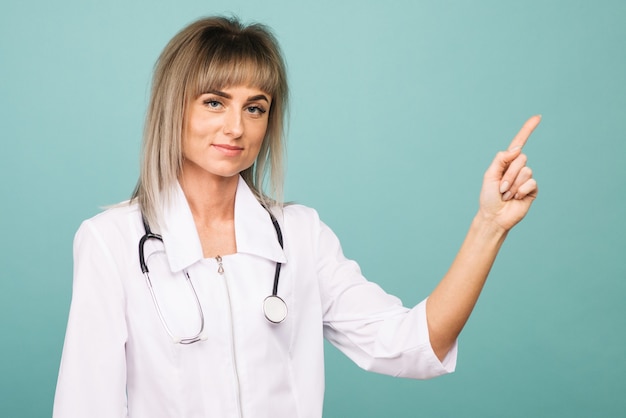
426, 116, 541, 359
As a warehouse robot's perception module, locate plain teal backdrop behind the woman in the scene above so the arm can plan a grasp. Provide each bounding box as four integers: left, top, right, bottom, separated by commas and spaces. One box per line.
0, 0, 626, 417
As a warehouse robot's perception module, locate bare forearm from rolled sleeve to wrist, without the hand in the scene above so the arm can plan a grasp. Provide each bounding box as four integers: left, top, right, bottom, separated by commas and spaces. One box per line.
426, 214, 507, 359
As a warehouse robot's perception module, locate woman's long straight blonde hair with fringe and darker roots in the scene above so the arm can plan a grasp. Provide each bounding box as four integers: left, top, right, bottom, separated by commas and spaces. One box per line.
132, 17, 288, 226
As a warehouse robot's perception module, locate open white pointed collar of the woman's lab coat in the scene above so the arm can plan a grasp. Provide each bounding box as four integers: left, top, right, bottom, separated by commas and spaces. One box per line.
161, 176, 287, 273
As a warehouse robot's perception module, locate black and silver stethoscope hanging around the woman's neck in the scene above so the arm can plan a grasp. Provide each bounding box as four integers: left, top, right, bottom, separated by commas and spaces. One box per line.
139, 210, 287, 344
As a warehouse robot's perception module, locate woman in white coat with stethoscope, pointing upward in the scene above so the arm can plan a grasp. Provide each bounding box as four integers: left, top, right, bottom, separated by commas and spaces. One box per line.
54, 14, 539, 418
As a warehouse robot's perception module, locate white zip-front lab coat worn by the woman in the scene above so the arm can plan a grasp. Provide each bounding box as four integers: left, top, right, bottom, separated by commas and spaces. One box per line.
54, 178, 456, 418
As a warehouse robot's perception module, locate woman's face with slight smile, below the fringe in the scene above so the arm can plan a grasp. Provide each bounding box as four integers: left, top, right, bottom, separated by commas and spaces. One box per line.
182, 86, 272, 179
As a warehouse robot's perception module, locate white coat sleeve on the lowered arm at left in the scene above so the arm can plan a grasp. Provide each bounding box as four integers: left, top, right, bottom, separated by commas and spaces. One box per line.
53, 221, 127, 418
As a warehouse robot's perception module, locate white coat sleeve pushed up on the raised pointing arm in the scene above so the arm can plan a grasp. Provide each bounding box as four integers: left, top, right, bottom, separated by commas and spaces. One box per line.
318, 222, 457, 379
